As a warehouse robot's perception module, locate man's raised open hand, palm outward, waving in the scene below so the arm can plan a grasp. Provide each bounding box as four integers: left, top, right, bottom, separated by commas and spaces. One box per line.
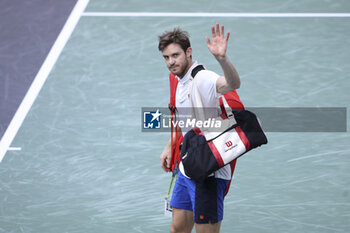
205, 23, 230, 59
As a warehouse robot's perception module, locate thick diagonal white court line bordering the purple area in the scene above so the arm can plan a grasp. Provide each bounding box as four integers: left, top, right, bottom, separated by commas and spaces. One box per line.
0, 0, 89, 162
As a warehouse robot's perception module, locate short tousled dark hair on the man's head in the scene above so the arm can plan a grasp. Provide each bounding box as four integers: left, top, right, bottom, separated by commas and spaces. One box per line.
158, 27, 191, 52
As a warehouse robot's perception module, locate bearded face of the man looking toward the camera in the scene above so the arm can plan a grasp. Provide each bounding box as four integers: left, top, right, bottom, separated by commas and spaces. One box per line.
162, 43, 192, 78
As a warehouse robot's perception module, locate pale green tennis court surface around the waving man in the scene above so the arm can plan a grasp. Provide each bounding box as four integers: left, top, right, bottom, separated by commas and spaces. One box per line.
0, 0, 350, 233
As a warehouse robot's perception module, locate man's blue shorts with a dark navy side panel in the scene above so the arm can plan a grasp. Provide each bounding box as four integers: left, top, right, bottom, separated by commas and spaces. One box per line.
170, 171, 229, 224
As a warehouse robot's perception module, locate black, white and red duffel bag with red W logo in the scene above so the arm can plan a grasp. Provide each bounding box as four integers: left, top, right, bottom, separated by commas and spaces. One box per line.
181, 105, 267, 181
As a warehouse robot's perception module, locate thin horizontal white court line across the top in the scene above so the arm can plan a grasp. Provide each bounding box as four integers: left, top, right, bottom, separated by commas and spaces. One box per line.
82, 12, 350, 18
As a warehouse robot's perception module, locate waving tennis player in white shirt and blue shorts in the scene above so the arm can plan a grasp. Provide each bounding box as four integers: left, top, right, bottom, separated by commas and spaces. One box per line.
158, 24, 240, 233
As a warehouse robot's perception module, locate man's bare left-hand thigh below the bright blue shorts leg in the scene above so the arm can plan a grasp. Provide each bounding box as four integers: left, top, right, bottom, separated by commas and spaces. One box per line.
170, 208, 194, 233
